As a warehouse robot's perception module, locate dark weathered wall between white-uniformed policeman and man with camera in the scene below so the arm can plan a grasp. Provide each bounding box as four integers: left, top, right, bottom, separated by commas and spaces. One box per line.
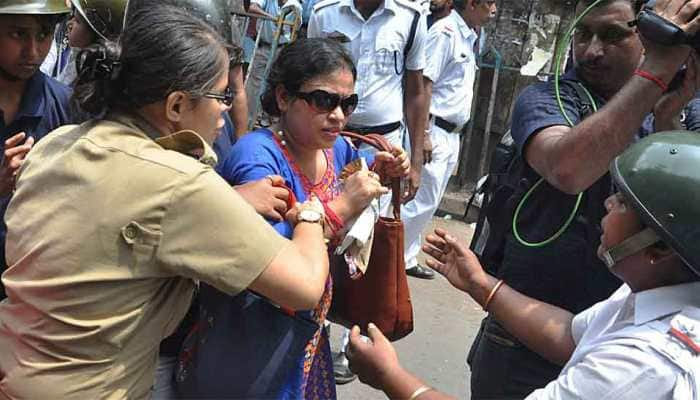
453, 0, 575, 190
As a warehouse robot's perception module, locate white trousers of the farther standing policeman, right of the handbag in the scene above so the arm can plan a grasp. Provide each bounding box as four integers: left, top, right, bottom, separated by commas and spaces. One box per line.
401, 125, 460, 269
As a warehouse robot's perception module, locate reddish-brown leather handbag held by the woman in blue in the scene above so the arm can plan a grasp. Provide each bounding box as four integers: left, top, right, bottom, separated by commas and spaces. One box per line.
329, 132, 413, 341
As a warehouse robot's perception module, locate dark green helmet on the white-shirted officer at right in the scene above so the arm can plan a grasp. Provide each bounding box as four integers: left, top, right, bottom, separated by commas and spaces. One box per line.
610, 131, 700, 274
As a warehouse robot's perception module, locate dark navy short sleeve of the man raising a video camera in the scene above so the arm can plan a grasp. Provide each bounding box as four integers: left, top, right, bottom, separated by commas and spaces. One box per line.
511, 82, 581, 154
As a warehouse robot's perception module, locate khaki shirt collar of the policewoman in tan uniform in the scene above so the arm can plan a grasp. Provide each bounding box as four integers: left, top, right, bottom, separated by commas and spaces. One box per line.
106, 112, 218, 168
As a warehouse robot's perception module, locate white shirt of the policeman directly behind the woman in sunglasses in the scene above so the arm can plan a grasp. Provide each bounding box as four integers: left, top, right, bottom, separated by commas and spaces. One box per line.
308, 0, 427, 126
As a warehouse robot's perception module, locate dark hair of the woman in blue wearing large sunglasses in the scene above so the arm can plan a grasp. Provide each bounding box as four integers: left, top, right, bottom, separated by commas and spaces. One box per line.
260, 38, 357, 117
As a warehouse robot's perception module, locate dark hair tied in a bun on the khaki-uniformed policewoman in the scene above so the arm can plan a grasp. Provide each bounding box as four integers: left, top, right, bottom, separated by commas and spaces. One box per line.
73, 6, 228, 116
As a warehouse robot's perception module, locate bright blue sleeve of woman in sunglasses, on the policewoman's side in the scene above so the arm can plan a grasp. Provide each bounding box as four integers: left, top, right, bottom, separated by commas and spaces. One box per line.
219, 131, 293, 238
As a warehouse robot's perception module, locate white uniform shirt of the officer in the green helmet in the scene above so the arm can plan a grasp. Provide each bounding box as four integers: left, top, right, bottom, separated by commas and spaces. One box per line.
527, 282, 700, 400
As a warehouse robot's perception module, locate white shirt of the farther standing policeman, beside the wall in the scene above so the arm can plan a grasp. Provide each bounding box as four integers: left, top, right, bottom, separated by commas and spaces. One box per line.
423, 10, 477, 126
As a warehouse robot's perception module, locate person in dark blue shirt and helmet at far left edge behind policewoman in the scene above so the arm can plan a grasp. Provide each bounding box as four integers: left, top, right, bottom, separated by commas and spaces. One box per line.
0, 0, 71, 299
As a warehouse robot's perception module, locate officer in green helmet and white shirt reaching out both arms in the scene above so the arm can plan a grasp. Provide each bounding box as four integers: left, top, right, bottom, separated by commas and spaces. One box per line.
349, 131, 700, 400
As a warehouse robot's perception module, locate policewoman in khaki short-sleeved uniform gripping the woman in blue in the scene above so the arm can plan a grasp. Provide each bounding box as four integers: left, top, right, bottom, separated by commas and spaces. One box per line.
0, 6, 328, 399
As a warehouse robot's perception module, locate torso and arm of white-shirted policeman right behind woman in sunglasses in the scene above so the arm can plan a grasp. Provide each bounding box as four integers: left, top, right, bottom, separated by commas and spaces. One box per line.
308, 0, 428, 208
